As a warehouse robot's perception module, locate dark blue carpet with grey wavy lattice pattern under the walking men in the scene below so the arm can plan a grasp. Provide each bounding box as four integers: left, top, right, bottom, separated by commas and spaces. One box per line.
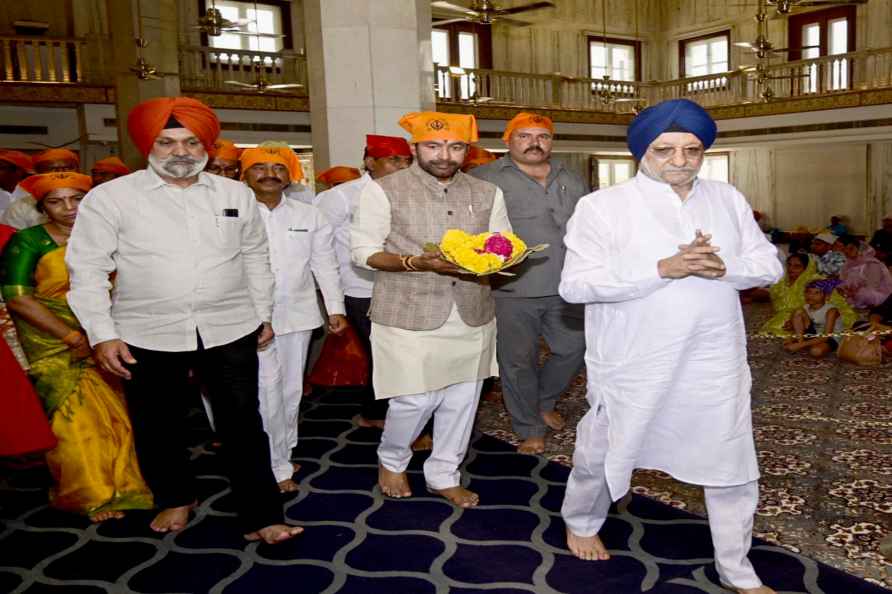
0, 394, 888, 594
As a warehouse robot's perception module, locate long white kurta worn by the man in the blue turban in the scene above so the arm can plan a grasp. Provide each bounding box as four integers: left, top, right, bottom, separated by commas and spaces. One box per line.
560, 172, 783, 500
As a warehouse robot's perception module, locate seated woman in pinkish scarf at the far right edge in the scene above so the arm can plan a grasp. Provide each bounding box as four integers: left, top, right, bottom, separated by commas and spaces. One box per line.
839, 235, 892, 308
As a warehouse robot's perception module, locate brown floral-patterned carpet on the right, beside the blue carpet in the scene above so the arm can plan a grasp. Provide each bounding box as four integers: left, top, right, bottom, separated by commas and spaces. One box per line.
478, 304, 892, 587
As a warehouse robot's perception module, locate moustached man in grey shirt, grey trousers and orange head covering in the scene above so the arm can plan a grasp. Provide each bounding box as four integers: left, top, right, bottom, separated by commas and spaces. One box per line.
471, 112, 589, 454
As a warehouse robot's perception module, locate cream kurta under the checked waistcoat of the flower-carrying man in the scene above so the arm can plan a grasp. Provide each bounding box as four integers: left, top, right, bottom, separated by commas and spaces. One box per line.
351, 178, 511, 399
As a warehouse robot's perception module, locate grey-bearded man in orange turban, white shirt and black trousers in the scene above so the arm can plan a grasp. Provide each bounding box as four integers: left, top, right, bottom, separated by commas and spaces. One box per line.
66, 97, 303, 544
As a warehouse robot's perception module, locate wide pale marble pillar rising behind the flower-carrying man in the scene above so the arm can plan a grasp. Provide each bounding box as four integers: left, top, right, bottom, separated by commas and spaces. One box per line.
304, 0, 435, 171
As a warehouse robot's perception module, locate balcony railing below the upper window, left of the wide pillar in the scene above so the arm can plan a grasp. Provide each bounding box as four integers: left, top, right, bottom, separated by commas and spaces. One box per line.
180, 46, 307, 95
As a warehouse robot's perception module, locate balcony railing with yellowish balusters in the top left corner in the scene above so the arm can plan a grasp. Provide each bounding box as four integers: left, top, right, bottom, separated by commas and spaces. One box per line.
0, 36, 86, 83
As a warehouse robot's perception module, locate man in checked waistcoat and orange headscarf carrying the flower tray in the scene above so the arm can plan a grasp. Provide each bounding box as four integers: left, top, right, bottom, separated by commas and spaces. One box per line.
350, 112, 511, 508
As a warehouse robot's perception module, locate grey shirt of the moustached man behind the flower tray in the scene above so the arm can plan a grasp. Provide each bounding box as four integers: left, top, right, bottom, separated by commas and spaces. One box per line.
469, 153, 589, 299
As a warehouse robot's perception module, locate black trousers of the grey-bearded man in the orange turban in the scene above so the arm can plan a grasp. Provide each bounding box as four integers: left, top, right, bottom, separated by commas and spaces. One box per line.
124, 330, 283, 533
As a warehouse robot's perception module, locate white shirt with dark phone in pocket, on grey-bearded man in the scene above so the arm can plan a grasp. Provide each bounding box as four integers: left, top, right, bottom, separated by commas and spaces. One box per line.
65, 169, 273, 351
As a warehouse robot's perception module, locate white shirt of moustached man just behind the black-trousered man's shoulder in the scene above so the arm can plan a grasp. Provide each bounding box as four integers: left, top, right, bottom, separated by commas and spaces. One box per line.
257, 194, 344, 334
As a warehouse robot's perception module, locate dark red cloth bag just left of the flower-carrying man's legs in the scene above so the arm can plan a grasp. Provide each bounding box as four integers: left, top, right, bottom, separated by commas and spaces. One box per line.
307, 326, 369, 388
